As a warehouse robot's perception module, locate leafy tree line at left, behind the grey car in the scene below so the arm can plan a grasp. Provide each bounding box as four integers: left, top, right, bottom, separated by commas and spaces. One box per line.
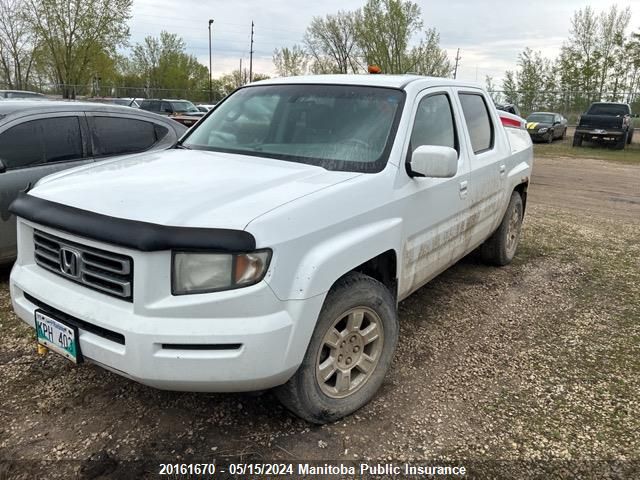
0, 0, 265, 100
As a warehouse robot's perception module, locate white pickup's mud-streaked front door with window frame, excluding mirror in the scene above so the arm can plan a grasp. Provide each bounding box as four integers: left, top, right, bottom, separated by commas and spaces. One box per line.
398, 87, 472, 298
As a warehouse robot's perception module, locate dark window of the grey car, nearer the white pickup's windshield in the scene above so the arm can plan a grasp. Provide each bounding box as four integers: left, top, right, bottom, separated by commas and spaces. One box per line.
91, 117, 159, 157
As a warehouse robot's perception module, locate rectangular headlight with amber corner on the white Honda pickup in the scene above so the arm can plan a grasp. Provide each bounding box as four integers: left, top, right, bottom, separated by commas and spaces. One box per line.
171, 250, 271, 295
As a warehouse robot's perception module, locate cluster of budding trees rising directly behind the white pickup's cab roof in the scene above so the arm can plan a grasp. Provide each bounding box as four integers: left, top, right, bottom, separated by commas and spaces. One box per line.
273, 0, 453, 77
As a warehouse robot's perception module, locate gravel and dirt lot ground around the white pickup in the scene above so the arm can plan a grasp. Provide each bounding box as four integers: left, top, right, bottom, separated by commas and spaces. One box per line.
0, 156, 640, 479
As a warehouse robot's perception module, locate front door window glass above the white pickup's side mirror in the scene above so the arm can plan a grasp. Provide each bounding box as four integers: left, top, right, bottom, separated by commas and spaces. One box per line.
411, 93, 458, 152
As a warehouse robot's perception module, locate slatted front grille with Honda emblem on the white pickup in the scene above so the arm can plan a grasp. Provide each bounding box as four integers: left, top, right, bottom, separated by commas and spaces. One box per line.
33, 230, 133, 301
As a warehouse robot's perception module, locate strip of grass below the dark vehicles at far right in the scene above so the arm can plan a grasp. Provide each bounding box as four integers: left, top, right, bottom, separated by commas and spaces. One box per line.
533, 139, 640, 164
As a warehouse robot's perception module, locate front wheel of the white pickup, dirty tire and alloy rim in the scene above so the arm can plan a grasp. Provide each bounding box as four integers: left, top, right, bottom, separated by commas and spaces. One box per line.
275, 272, 399, 424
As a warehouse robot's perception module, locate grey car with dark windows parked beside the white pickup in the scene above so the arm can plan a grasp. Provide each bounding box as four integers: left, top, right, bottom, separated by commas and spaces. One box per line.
0, 100, 187, 263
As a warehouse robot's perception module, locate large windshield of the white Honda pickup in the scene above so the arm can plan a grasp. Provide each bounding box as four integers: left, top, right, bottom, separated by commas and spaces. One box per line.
184, 85, 404, 172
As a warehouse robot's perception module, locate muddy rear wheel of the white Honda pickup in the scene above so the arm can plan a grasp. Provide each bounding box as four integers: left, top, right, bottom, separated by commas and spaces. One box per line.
480, 192, 524, 267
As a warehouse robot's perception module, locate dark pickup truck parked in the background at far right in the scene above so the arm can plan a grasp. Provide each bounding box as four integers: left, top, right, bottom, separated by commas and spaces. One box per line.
573, 102, 633, 150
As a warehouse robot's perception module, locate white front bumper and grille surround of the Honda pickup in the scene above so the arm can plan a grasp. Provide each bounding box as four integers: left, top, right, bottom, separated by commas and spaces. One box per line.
10, 221, 324, 392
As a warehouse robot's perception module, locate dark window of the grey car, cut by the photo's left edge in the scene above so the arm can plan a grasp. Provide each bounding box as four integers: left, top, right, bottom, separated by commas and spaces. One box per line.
0, 117, 83, 169
